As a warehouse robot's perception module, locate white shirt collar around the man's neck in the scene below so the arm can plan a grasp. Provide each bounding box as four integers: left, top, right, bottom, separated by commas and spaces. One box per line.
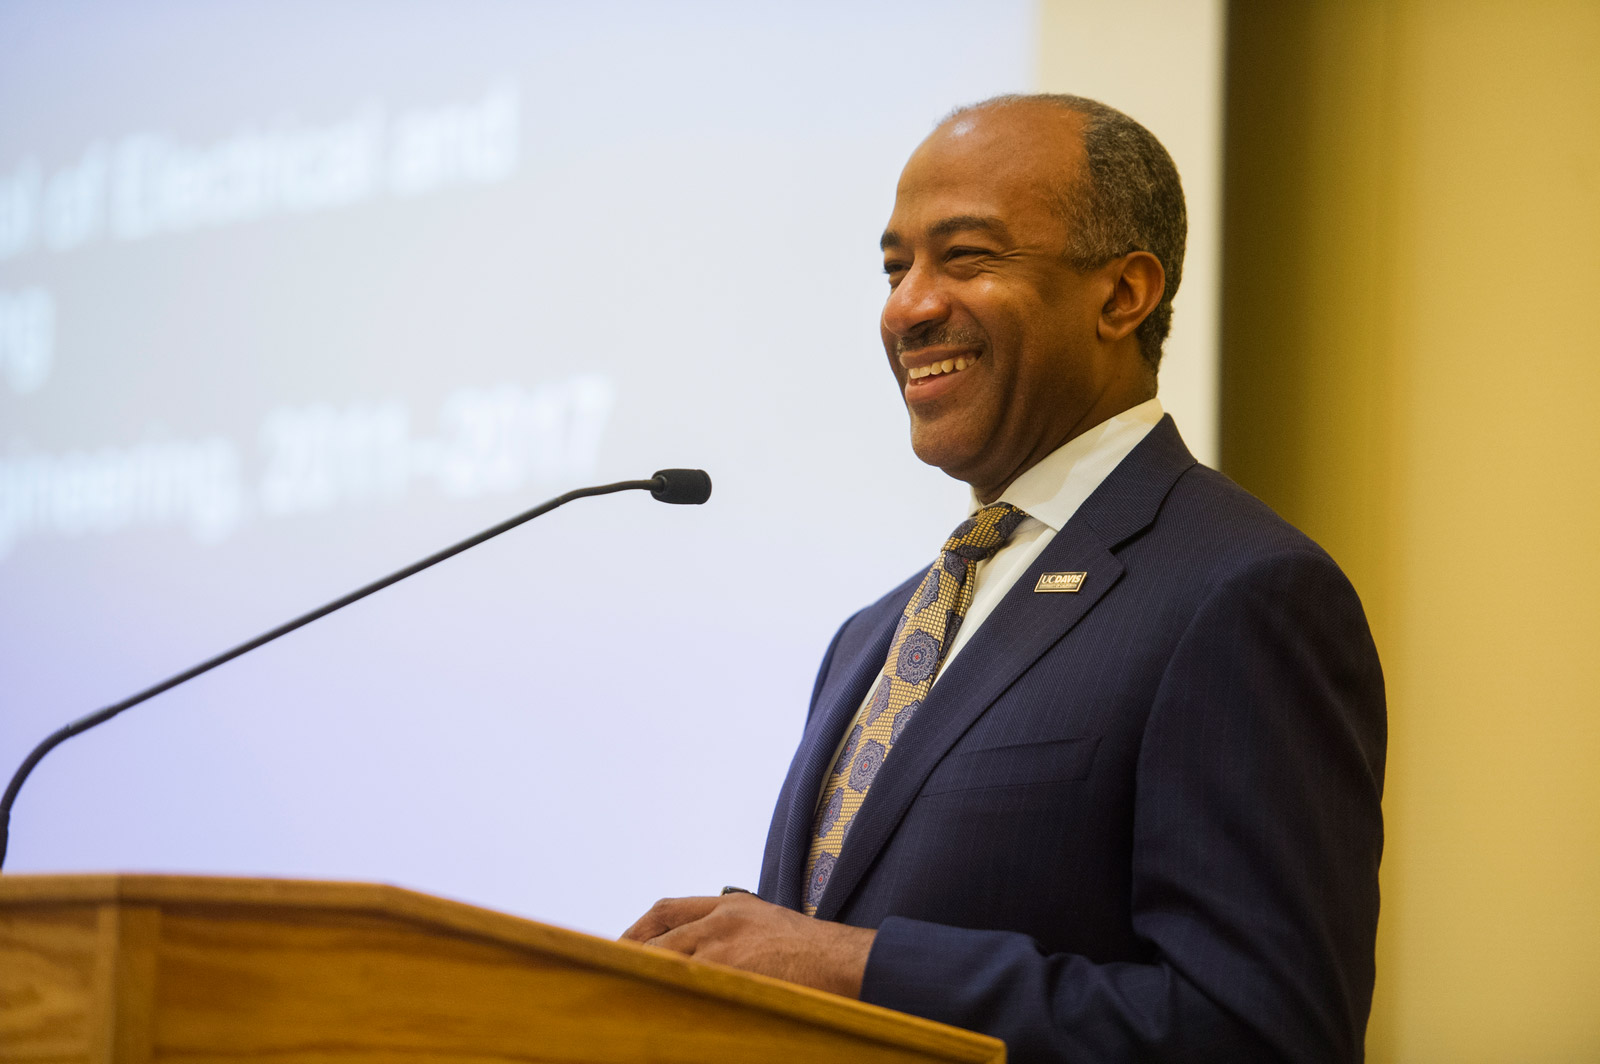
968, 398, 1163, 531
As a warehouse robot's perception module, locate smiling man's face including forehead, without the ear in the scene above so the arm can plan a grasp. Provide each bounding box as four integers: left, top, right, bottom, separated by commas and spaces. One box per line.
882, 106, 1115, 501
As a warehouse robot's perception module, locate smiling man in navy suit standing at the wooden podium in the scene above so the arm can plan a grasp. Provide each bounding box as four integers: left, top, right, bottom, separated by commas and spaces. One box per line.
626, 96, 1386, 1062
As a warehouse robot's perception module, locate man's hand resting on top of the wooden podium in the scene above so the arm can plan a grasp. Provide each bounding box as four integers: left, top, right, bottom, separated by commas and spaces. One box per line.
622, 893, 877, 997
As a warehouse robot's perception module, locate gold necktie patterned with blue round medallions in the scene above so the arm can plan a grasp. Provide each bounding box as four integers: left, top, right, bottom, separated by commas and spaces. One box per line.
805, 502, 1027, 917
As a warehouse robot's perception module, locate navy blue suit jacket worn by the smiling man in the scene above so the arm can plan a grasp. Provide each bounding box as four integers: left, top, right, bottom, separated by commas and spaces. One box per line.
760, 418, 1386, 1064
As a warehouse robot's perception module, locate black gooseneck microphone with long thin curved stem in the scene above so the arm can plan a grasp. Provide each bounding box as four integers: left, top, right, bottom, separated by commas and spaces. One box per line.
0, 469, 710, 869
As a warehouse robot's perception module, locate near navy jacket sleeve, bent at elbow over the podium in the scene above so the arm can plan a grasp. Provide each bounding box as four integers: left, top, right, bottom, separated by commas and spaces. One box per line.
862, 549, 1386, 1064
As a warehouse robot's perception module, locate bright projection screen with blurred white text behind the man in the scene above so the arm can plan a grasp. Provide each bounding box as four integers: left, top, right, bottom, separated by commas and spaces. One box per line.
0, 0, 1214, 934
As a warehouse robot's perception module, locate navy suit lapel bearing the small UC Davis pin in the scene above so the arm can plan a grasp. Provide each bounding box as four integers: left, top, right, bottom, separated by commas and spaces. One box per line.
812, 416, 1195, 920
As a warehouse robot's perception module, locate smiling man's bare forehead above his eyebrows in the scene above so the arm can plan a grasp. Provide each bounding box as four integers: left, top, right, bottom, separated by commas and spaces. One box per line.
885, 106, 1083, 242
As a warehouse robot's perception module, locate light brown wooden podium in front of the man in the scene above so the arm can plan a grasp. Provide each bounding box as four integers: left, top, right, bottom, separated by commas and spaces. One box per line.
0, 875, 1005, 1064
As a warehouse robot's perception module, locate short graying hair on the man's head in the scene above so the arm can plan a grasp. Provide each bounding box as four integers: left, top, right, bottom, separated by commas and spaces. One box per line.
939, 93, 1189, 370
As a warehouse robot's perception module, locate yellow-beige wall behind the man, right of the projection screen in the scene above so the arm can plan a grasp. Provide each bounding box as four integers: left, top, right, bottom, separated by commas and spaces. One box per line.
1043, 0, 1600, 1062
